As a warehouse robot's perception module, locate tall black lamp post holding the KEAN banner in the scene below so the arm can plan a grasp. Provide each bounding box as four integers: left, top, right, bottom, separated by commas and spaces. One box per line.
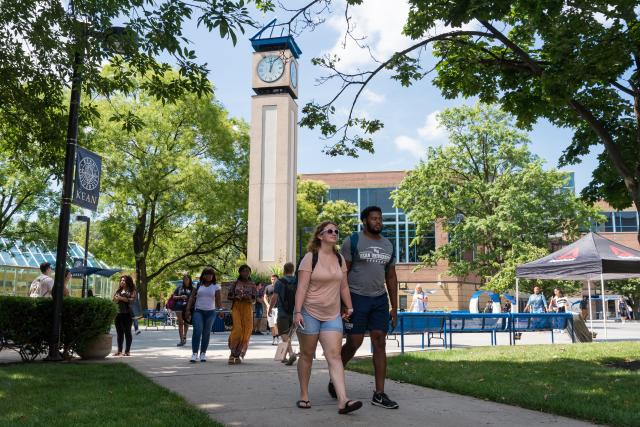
46, 23, 129, 361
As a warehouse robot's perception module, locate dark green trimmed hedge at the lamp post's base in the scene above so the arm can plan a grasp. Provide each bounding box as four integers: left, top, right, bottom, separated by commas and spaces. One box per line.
0, 296, 116, 361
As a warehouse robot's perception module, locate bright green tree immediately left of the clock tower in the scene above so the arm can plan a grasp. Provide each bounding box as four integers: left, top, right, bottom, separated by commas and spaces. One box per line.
86, 69, 248, 306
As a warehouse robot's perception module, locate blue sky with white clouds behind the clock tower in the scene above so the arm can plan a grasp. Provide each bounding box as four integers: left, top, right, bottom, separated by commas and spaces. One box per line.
174, 0, 601, 191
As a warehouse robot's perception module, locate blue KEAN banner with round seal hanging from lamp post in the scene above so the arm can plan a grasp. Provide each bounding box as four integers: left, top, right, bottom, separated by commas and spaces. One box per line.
72, 147, 102, 212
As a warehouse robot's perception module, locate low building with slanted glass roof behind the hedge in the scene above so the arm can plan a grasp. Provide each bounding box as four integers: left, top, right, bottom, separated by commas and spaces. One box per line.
0, 237, 116, 298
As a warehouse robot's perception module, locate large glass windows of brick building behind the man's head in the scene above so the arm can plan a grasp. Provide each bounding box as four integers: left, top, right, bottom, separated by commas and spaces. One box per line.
329, 187, 436, 263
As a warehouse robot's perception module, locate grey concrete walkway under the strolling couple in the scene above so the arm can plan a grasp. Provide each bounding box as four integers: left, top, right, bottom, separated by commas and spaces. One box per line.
119, 329, 592, 427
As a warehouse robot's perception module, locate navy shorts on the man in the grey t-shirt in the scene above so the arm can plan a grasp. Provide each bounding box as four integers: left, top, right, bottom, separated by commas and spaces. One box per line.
344, 292, 390, 335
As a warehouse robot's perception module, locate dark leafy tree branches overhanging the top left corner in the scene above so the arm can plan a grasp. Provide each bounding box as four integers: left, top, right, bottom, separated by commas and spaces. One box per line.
0, 0, 273, 174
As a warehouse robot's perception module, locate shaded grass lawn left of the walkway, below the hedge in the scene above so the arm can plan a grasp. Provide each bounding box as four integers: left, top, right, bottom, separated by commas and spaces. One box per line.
0, 363, 222, 427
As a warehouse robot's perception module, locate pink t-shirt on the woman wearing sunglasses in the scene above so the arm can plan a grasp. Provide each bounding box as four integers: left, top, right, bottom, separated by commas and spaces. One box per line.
299, 252, 347, 321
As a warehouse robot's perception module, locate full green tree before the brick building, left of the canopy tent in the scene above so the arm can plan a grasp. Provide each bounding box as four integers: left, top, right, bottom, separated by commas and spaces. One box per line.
393, 104, 598, 290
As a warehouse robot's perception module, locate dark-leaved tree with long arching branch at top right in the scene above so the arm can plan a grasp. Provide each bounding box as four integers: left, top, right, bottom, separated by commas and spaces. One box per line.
292, 0, 640, 242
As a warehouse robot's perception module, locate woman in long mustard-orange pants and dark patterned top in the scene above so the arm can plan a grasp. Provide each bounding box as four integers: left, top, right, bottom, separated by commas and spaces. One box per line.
228, 264, 258, 365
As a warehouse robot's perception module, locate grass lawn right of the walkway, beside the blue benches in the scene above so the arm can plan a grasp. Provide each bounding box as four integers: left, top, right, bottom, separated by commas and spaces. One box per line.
348, 342, 640, 426
